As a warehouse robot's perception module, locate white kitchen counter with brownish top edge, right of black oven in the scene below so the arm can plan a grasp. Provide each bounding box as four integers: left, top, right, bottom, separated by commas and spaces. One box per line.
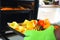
37, 5, 60, 24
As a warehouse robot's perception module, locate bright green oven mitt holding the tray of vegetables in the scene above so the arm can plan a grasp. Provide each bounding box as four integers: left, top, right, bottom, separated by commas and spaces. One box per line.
24, 25, 56, 40
